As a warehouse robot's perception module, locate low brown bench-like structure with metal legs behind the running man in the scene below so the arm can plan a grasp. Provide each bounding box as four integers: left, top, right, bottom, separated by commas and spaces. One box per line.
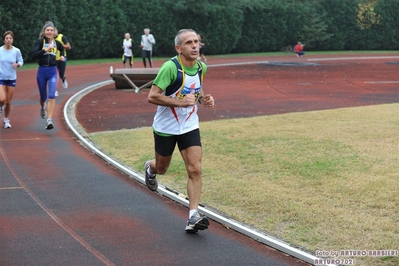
110, 67, 159, 93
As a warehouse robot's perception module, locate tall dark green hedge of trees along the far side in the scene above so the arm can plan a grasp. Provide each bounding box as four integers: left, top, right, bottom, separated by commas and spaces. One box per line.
0, 0, 399, 61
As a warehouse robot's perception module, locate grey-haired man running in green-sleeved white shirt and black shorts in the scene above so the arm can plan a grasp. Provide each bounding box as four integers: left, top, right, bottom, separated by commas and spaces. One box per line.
144, 29, 214, 233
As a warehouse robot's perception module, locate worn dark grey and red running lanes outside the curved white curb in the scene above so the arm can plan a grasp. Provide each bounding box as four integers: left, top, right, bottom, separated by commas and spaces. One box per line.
0, 60, 307, 265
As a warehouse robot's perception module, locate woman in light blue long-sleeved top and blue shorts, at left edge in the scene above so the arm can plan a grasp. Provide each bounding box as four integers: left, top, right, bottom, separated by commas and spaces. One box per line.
0, 31, 24, 128
